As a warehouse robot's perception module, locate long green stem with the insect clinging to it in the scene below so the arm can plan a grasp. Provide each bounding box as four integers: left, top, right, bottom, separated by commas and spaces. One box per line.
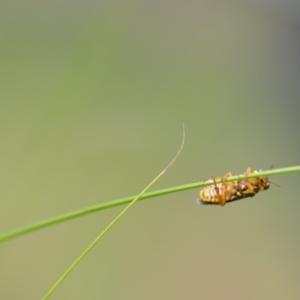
0, 166, 300, 243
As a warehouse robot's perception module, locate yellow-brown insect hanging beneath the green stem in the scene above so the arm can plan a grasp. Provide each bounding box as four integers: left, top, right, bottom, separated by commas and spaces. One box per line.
197, 168, 270, 206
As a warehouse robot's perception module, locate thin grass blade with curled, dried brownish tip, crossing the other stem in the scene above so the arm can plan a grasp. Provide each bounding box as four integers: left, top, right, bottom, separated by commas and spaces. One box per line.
43, 123, 185, 300
